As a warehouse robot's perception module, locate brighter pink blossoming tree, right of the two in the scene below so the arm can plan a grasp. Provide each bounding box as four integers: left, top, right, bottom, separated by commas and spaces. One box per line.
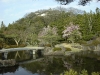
62, 22, 81, 43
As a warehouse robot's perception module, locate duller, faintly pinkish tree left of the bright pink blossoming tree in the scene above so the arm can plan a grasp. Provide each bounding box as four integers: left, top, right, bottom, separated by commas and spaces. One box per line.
38, 26, 59, 47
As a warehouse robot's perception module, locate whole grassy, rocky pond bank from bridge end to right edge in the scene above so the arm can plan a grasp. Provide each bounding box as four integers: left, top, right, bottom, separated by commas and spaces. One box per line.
44, 43, 100, 59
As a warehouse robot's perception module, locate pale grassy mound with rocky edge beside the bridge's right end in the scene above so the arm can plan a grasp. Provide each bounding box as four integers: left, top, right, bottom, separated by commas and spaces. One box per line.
44, 43, 82, 56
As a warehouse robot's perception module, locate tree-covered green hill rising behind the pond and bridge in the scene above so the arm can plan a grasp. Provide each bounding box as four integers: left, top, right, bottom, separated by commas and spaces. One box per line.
0, 7, 100, 48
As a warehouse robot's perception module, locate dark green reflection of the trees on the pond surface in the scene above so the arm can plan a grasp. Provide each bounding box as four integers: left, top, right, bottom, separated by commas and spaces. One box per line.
0, 52, 100, 75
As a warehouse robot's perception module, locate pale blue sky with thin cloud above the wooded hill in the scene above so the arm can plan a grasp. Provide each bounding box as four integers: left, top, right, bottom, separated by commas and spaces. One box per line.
0, 0, 100, 26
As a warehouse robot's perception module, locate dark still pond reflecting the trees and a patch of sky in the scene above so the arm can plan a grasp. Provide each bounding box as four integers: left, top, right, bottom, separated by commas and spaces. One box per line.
0, 52, 100, 75
